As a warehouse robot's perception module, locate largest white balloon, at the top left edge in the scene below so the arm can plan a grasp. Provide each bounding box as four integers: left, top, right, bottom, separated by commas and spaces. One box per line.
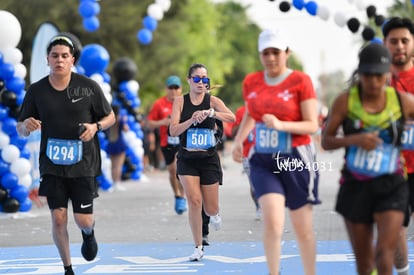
0, 10, 22, 52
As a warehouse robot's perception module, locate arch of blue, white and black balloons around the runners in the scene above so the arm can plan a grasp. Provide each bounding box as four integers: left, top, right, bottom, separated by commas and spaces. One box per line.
0, 0, 414, 213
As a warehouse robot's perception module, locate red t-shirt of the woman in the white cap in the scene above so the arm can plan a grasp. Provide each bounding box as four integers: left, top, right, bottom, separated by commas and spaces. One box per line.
243, 71, 316, 147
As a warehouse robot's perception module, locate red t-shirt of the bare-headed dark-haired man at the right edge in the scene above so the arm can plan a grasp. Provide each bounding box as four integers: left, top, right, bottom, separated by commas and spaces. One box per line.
391, 67, 414, 174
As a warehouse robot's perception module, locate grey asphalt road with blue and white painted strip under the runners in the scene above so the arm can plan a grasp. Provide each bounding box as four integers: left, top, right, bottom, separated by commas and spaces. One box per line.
0, 146, 413, 275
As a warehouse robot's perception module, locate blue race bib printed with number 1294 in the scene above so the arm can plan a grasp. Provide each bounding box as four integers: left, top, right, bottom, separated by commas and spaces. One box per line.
46, 138, 83, 165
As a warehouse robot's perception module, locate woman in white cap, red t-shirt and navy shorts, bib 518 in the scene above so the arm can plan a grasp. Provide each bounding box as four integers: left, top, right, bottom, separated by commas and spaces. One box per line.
232, 30, 320, 275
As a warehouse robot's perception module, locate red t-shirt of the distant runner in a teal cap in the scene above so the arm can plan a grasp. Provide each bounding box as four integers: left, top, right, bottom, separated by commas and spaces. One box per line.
148, 96, 173, 147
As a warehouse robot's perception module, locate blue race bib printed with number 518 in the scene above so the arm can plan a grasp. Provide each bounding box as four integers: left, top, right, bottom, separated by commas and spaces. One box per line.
255, 123, 292, 154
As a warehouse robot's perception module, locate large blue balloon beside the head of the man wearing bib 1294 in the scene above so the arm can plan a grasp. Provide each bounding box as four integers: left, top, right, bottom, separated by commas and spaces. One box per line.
79, 44, 110, 76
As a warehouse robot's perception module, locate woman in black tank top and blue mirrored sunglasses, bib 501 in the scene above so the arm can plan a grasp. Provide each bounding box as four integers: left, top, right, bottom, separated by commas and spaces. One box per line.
170, 64, 235, 261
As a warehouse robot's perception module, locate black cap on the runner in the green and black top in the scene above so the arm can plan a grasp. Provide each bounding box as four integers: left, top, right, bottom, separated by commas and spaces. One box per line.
358, 43, 391, 74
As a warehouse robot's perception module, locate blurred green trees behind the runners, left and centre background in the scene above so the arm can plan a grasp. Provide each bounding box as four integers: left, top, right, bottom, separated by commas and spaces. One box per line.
0, 0, 308, 112
